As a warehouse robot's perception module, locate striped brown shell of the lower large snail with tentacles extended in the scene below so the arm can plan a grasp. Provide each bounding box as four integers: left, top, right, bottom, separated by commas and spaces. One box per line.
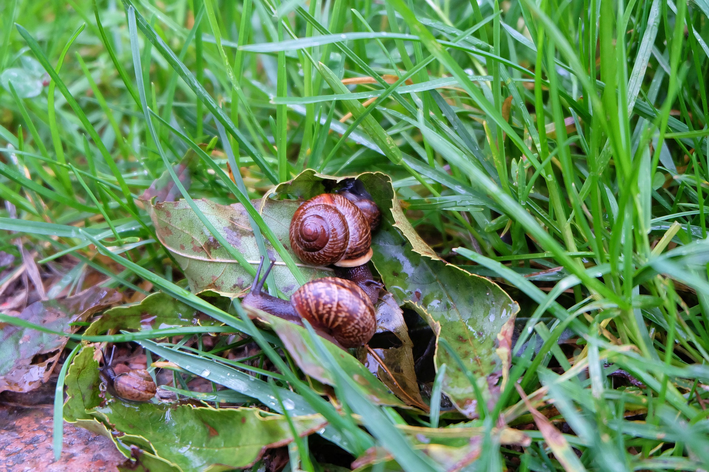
291, 277, 377, 347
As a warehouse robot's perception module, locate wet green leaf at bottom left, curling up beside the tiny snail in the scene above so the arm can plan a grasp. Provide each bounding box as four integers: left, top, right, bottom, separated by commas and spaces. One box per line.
64, 346, 326, 471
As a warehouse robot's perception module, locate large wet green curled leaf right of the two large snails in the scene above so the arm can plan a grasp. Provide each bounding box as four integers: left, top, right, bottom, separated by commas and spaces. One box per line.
361, 174, 519, 416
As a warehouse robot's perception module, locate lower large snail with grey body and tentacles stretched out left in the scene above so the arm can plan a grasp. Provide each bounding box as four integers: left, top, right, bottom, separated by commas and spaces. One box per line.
242, 257, 381, 348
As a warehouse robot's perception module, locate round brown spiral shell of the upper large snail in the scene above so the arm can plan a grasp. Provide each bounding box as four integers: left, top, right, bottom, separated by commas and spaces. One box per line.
289, 193, 372, 265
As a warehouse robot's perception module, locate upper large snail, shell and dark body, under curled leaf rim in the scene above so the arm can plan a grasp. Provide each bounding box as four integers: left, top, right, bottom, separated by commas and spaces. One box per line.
289, 180, 381, 267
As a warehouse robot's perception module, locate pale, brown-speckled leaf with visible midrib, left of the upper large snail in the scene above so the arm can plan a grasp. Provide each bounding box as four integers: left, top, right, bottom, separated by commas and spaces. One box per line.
150, 196, 332, 297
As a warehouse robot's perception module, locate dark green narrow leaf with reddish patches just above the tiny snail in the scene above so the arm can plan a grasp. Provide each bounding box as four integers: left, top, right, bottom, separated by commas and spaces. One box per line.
85, 292, 220, 336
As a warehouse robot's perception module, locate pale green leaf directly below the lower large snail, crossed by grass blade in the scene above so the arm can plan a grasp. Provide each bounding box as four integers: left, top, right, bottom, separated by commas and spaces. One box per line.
260, 314, 405, 407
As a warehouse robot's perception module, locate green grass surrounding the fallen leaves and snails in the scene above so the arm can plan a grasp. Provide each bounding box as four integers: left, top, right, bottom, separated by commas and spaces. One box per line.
0, 0, 709, 471
